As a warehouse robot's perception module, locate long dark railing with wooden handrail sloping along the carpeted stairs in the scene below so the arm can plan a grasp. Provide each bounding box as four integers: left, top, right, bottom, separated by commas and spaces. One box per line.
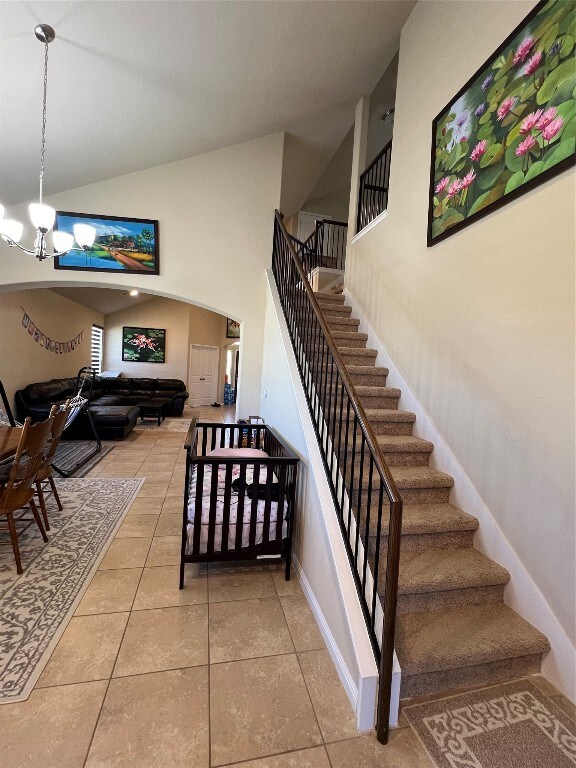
272, 211, 402, 744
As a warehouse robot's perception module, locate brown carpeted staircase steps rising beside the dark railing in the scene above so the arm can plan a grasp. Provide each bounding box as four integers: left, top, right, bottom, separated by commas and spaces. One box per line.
315, 286, 549, 698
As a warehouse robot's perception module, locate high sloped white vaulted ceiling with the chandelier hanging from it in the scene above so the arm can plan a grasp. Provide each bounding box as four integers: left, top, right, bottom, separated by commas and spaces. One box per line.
0, 0, 414, 204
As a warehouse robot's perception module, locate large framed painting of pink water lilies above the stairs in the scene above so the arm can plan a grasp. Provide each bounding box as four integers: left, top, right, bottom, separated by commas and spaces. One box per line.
428, 0, 576, 246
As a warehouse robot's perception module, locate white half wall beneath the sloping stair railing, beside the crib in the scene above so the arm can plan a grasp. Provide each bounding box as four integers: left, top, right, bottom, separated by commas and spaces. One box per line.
259, 274, 377, 730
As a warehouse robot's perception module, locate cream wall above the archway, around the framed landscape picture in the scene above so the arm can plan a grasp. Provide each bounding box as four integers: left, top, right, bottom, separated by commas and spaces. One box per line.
0, 133, 284, 413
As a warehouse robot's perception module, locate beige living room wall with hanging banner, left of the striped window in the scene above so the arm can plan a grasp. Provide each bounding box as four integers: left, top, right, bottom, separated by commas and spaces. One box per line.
0, 289, 104, 405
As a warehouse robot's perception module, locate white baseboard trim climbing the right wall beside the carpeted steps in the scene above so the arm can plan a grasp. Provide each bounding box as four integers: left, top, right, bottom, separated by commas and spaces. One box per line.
344, 286, 576, 702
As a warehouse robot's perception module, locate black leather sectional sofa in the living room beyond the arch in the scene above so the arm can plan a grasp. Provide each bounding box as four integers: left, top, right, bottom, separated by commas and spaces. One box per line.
14, 376, 188, 440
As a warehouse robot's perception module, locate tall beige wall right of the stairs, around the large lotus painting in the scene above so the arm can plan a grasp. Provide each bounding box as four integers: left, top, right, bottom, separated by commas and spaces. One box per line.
346, 2, 575, 639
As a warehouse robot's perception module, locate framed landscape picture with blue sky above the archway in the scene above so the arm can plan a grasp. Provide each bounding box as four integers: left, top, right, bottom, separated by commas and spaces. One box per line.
54, 211, 160, 275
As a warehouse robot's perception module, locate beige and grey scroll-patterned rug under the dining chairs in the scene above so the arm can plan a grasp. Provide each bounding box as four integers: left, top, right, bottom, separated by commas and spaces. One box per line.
0, 478, 144, 704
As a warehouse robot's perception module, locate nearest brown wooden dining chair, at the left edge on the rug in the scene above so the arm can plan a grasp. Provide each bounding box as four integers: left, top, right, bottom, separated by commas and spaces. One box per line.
0, 416, 54, 574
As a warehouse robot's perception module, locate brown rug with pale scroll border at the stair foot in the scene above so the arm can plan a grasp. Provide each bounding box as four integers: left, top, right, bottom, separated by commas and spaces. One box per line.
403, 680, 576, 768
